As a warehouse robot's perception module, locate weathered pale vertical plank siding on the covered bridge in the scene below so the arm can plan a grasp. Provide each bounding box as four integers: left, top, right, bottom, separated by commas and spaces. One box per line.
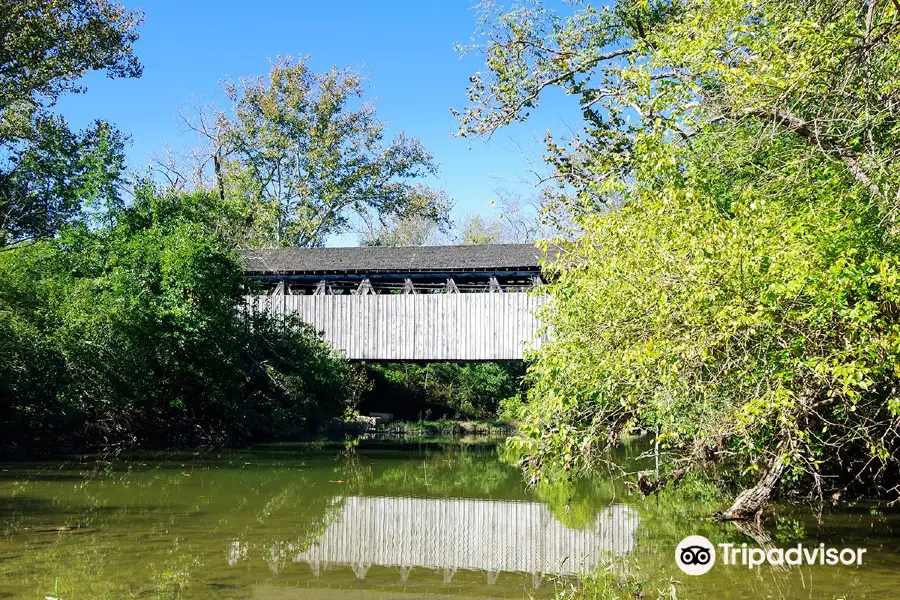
243, 292, 542, 360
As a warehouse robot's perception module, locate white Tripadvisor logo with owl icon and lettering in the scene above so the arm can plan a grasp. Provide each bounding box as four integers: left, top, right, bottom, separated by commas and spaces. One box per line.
675, 535, 866, 575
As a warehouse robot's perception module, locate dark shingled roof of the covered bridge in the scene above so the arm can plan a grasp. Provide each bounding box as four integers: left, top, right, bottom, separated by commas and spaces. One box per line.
240, 244, 542, 274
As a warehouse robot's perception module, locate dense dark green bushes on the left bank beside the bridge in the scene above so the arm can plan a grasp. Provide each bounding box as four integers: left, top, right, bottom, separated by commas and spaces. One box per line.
0, 186, 354, 443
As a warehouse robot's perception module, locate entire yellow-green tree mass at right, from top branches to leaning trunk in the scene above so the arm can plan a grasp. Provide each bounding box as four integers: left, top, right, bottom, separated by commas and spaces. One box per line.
457, 0, 900, 518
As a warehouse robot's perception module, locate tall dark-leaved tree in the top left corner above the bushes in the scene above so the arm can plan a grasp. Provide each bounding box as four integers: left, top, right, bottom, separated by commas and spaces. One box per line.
0, 0, 142, 249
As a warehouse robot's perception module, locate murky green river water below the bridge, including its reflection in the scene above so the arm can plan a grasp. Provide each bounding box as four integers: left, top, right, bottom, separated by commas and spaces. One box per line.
0, 439, 900, 600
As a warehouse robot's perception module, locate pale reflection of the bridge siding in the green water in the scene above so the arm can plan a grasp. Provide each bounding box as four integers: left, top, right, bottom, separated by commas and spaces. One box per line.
293, 496, 638, 583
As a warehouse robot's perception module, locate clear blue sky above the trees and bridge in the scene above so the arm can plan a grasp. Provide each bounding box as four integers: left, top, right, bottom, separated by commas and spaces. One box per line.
58, 0, 578, 244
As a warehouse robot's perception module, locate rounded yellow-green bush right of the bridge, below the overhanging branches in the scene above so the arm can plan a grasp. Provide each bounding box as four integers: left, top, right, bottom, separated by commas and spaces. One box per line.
512, 135, 898, 492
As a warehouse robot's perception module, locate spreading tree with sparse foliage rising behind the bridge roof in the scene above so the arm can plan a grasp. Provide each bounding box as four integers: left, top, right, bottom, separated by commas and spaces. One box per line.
162, 57, 447, 246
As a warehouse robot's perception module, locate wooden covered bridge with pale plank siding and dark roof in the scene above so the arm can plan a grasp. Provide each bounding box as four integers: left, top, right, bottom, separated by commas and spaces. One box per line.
242, 244, 542, 361
